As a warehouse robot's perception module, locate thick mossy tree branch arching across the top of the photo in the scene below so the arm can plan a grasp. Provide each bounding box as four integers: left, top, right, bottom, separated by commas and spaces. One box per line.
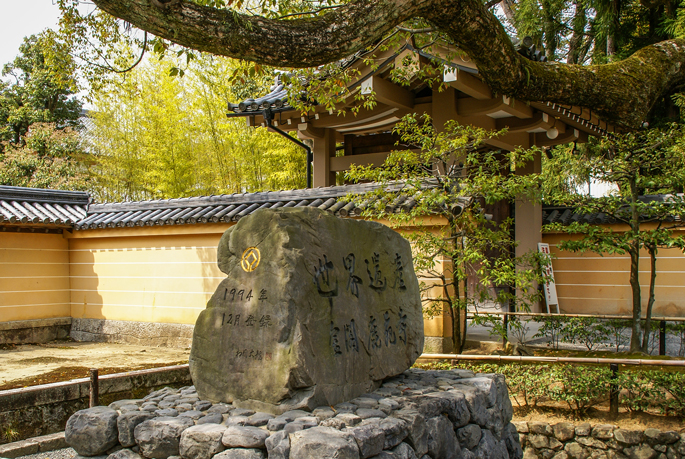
94, 0, 685, 128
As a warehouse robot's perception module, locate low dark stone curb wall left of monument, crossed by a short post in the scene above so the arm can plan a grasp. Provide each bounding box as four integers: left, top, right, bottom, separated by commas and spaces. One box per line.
0, 364, 192, 444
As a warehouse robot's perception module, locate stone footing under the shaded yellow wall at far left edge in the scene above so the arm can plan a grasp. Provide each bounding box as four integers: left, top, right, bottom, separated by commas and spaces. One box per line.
0, 317, 71, 344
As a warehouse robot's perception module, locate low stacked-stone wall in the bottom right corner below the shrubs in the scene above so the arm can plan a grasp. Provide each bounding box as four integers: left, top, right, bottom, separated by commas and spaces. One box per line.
512, 421, 685, 459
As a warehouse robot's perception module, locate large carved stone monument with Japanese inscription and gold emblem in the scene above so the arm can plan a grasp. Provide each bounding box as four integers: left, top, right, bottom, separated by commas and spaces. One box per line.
190, 207, 423, 413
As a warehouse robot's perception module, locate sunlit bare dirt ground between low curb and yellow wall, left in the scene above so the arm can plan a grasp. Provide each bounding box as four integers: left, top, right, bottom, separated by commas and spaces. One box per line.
0, 341, 190, 390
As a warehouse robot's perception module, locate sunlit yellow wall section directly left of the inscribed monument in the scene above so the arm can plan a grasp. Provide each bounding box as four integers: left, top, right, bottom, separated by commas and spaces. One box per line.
69, 224, 230, 324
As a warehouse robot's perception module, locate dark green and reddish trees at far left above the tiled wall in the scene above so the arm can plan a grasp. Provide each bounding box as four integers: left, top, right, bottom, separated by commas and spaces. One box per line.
0, 32, 88, 190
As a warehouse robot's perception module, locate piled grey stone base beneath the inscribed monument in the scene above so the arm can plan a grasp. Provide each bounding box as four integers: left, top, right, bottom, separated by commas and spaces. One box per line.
65, 369, 523, 459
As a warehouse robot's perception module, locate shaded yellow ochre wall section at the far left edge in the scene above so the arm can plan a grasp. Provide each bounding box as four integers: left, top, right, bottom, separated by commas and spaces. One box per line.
0, 232, 71, 322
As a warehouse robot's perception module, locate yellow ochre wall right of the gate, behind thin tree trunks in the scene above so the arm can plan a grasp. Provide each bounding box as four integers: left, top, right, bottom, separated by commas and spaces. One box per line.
542, 234, 685, 317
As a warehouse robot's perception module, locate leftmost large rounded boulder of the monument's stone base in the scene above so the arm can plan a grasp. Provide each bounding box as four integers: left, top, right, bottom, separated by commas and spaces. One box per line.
64, 406, 119, 456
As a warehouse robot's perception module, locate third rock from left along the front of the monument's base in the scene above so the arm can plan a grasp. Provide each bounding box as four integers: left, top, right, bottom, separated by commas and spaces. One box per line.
134, 417, 193, 459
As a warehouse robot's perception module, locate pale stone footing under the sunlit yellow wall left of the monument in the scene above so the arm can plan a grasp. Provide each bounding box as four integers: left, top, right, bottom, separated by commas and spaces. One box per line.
70, 319, 195, 349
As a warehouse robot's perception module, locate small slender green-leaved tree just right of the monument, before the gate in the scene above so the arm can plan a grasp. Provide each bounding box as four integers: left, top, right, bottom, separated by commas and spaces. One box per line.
347, 115, 543, 351
